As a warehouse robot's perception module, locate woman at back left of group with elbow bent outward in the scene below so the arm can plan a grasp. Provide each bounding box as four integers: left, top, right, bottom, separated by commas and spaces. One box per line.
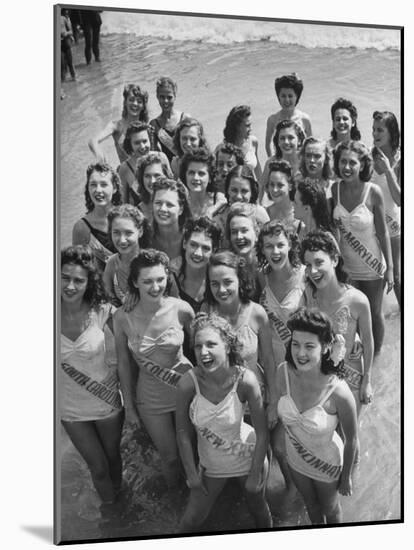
88, 84, 148, 162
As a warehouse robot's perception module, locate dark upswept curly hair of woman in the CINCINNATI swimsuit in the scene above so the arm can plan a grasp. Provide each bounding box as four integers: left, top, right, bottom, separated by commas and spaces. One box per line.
286, 307, 344, 378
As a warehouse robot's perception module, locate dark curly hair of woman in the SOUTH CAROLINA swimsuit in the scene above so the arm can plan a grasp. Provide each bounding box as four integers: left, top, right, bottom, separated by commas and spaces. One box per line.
60, 244, 107, 311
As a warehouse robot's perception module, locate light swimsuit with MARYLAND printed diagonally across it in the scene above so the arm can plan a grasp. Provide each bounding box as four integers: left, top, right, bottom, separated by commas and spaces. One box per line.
333, 182, 385, 281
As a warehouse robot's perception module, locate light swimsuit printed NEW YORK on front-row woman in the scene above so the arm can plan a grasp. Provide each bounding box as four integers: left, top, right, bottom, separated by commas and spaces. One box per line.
189, 369, 256, 477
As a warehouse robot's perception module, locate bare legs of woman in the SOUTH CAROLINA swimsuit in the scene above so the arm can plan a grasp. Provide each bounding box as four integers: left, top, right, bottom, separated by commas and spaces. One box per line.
62, 420, 116, 503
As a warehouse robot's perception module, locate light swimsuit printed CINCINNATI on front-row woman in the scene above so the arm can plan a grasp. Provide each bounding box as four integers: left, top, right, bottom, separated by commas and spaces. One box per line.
277, 362, 345, 482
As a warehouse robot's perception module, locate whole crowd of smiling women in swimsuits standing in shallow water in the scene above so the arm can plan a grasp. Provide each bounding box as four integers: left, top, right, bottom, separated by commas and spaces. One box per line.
60, 75, 400, 532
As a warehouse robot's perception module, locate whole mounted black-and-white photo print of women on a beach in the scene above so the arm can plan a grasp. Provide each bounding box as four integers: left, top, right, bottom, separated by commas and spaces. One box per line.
55, 5, 403, 544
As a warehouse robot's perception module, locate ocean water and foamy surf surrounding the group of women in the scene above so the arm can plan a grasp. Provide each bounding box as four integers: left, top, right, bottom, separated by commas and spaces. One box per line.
58, 8, 401, 540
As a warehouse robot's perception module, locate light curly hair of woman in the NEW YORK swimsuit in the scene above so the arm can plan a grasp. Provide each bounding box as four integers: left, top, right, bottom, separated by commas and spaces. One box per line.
190, 312, 245, 367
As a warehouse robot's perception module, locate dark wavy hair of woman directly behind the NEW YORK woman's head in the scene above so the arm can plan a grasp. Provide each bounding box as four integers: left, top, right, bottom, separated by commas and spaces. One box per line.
204, 248, 255, 305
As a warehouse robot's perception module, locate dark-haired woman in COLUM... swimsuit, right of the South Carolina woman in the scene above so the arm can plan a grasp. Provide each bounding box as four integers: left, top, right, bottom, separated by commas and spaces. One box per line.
114, 249, 194, 488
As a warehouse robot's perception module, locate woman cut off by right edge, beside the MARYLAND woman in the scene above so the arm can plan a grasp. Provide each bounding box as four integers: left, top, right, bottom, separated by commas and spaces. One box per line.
372, 111, 401, 306
